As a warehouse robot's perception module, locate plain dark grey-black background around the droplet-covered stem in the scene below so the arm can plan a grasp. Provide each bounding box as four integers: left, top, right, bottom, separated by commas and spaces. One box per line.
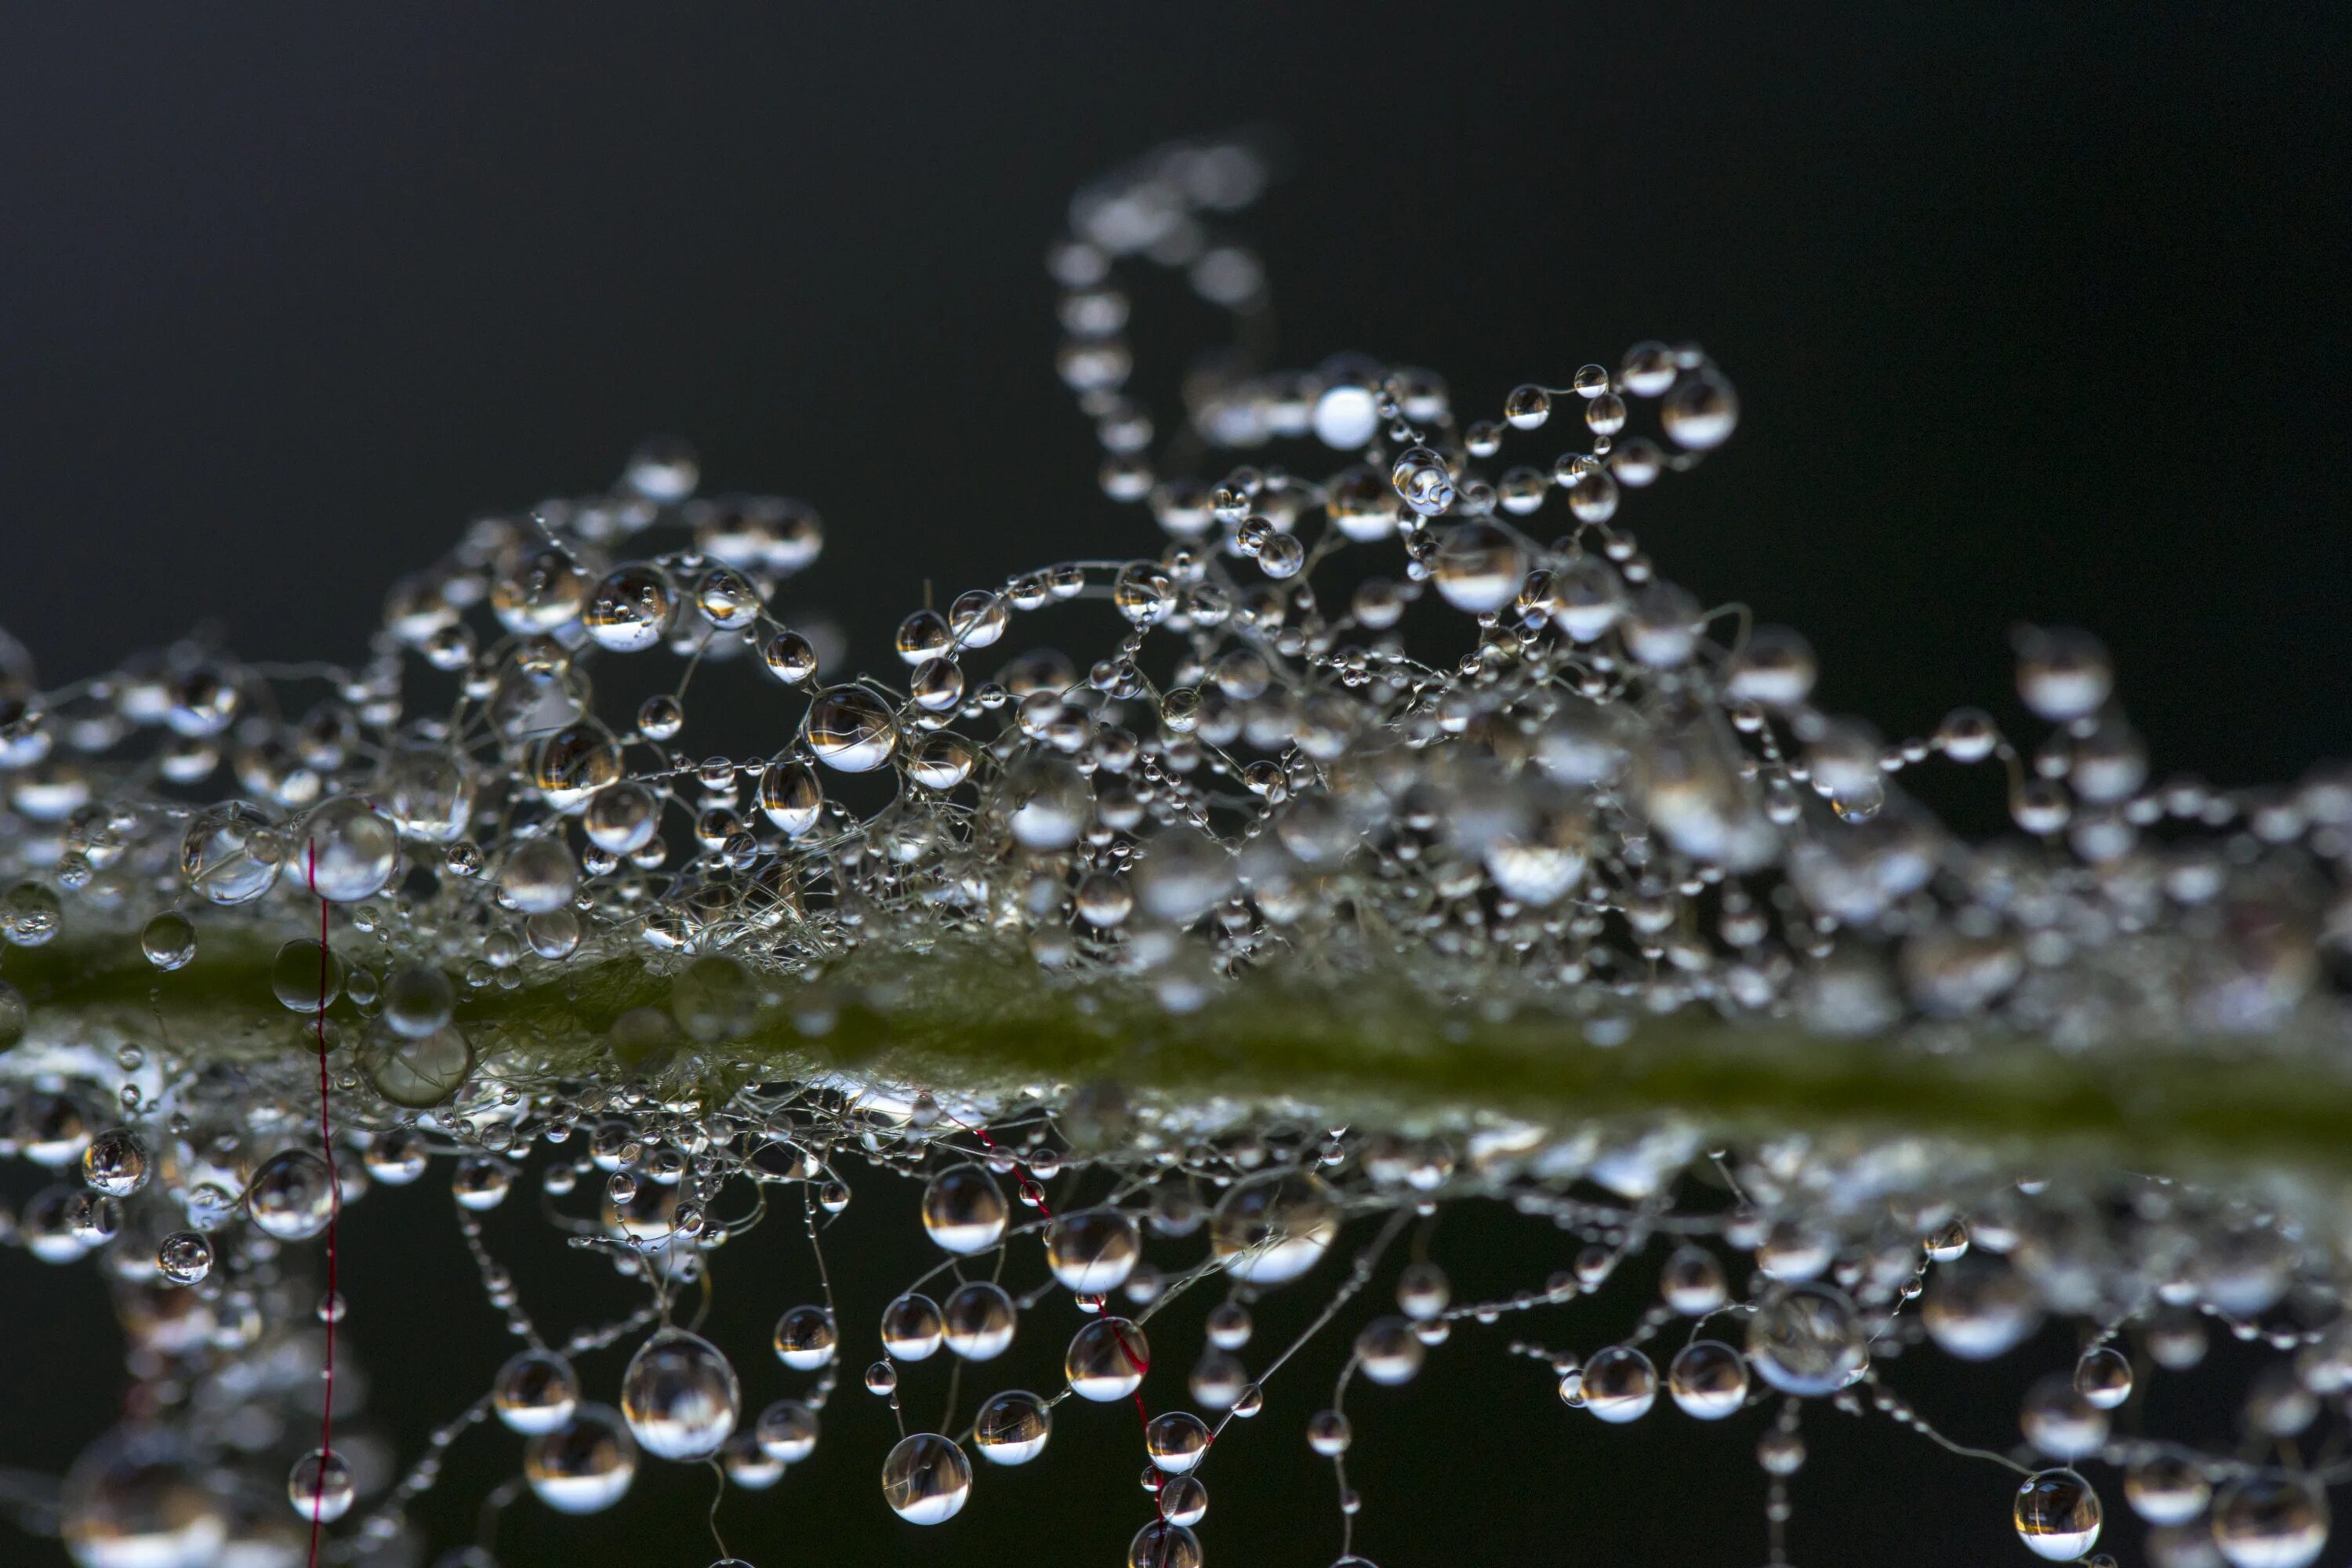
0, 5, 2352, 1568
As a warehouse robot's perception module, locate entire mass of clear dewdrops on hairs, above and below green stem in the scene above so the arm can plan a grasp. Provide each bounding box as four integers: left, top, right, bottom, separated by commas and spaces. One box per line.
0, 131, 2352, 1568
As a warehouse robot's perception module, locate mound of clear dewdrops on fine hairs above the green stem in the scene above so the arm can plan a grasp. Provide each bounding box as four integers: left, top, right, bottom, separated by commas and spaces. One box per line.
0, 146, 2352, 1072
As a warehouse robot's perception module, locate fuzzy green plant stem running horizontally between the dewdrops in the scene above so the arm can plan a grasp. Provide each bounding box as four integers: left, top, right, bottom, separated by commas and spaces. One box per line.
5, 940, 2352, 1175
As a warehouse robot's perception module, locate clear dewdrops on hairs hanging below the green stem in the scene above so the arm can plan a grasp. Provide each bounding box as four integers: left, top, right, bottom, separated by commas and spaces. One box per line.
0, 1048, 2352, 1568
